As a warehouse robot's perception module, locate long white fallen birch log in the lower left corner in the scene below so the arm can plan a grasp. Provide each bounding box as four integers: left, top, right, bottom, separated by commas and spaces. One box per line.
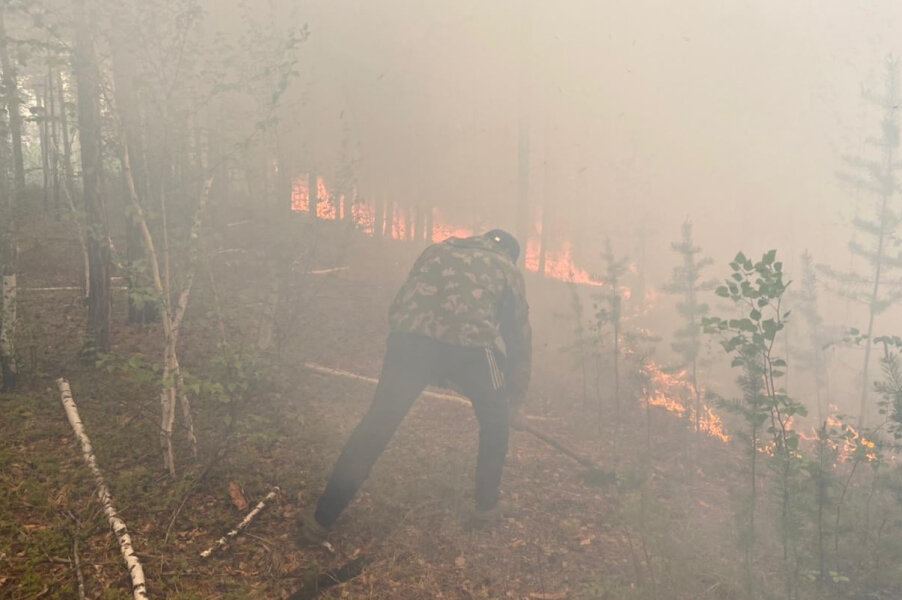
56, 378, 147, 600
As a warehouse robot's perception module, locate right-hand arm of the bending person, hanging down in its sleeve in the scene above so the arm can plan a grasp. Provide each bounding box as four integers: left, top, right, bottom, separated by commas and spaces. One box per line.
499, 271, 532, 406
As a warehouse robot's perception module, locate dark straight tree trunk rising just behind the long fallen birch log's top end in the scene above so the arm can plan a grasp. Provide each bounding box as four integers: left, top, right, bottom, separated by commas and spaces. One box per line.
74, 0, 112, 357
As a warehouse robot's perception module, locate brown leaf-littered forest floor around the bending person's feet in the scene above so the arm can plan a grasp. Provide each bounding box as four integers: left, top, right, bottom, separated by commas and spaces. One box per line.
0, 217, 824, 600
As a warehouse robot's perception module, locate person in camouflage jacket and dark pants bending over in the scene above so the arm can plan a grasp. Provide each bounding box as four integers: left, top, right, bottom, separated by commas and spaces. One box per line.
299, 229, 532, 544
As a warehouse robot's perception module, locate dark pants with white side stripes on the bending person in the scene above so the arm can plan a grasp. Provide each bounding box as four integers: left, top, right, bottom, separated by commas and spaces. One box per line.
316, 333, 508, 528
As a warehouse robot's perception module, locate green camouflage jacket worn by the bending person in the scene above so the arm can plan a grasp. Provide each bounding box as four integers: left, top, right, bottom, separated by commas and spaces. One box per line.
389, 237, 532, 404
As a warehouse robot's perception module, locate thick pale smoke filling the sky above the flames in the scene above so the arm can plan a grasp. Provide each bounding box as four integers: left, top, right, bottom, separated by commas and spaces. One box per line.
238, 0, 902, 284
